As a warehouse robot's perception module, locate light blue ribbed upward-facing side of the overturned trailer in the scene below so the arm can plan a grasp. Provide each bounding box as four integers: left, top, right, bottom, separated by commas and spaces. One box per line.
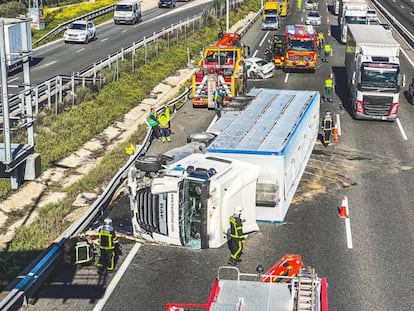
207, 88, 319, 155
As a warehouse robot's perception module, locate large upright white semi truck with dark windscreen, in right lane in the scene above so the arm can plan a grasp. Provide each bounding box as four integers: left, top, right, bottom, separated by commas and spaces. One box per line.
345, 25, 405, 121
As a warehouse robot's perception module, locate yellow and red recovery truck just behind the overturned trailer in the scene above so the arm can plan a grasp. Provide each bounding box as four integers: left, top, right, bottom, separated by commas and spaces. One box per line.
192, 33, 247, 108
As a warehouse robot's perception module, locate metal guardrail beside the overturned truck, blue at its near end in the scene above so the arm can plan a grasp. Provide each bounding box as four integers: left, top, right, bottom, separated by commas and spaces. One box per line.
0, 11, 261, 310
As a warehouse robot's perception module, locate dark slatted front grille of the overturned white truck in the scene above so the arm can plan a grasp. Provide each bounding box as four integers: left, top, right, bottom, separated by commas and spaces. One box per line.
135, 188, 164, 233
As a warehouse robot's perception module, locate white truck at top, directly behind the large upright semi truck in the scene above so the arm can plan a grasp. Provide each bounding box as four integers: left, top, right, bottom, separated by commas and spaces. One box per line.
338, 0, 368, 43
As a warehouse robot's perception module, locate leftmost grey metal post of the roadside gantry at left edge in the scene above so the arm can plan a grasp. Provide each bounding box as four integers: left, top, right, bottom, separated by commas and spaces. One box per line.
0, 19, 13, 164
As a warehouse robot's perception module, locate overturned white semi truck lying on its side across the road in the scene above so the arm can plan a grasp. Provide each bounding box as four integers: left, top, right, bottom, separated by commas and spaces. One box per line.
128, 89, 320, 249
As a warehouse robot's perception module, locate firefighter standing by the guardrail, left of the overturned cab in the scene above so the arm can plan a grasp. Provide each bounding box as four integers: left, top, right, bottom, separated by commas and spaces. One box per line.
96, 218, 118, 274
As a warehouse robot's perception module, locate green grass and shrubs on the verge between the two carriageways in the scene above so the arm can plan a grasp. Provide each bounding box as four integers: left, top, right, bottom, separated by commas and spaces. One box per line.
0, 0, 260, 289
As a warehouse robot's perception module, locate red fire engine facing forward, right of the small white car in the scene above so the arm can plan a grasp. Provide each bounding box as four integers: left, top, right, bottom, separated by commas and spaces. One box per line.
284, 25, 318, 71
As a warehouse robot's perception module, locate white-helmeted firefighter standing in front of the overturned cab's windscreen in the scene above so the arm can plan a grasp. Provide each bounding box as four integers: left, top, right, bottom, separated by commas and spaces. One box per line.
227, 206, 245, 266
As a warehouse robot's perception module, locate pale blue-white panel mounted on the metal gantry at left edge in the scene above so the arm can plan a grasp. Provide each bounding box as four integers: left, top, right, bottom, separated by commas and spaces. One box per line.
1, 18, 33, 71
